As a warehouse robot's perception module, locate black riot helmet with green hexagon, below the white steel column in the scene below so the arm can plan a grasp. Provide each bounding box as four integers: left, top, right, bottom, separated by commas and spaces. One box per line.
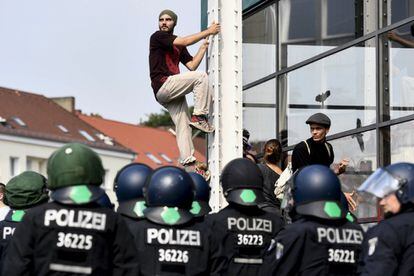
220, 158, 265, 206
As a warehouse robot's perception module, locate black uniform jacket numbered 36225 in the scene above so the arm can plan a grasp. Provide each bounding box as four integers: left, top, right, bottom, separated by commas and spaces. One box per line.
3, 202, 138, 276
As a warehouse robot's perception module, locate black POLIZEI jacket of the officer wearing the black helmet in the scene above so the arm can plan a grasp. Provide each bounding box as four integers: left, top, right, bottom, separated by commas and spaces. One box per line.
206, 204, 283, 276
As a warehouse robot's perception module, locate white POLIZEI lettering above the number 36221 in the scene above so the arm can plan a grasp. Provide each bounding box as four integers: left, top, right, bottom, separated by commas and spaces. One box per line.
317, 227, 364, 244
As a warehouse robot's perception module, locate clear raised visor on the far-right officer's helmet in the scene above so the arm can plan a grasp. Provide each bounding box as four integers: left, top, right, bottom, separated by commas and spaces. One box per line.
358, 168, 400, 198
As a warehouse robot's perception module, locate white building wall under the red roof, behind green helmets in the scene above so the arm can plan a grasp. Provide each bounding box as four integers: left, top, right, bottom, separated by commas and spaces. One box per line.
0, 134, 134, 203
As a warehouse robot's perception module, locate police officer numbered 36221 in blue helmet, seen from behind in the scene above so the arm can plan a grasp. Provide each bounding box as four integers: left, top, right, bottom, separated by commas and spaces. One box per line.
263, 165, 364, 276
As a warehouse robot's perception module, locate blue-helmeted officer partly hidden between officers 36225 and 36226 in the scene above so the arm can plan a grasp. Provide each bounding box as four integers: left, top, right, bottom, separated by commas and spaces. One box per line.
114, 163, 153, 226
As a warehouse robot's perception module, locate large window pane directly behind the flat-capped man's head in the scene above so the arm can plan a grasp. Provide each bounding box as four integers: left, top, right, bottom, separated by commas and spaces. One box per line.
279, 40, 376, 145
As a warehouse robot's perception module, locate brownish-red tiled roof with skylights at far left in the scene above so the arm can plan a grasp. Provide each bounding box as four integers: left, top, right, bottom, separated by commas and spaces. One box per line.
0, 87, 132, 153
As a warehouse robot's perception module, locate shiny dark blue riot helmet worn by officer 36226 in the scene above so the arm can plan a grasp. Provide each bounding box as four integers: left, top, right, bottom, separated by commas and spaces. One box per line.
144, 166, 194, 225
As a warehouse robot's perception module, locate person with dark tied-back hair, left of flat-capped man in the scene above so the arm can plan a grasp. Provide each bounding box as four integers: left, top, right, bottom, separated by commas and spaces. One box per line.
258, 139, 282, 213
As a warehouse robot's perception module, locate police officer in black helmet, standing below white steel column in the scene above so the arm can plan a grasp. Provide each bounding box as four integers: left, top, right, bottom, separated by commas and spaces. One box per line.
207, 158, 282, 275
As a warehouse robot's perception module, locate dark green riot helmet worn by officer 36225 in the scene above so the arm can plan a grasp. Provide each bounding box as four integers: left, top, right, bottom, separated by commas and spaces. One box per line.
47, 143, 105, 204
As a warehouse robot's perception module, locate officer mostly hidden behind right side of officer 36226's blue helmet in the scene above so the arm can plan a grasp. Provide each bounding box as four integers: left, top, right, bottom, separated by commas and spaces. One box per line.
189, 172, 211, 221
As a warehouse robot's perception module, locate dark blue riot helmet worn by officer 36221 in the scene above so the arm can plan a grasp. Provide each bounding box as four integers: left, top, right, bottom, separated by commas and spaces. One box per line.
292, 165, 346, 219
